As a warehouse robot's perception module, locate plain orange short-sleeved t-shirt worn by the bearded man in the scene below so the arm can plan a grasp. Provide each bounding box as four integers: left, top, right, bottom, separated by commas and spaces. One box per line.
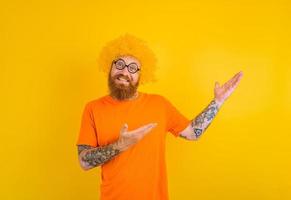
77, 92, 190, 200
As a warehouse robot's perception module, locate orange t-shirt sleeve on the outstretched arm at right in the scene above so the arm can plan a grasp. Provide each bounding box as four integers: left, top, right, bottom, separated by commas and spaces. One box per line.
164, 98, 191, 137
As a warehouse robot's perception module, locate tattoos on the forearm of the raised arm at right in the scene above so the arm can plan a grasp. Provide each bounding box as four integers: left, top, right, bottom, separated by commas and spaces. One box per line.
181, 100, 220, 139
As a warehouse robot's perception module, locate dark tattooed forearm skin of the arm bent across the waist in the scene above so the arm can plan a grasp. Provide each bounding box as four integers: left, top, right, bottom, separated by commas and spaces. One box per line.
78, 144, 120, 168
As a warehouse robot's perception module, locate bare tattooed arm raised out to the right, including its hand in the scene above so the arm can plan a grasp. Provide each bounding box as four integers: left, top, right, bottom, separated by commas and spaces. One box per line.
179, 72, 242, 140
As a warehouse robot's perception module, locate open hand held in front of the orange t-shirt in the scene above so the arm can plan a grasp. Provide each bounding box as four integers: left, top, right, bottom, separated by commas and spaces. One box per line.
115, 123, 157, 151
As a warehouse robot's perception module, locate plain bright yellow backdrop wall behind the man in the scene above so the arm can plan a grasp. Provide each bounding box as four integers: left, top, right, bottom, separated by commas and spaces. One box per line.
0, 0, 291, 200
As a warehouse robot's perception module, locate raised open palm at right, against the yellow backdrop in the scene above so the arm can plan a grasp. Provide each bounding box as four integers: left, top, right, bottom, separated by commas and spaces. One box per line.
214, 71, 243, 104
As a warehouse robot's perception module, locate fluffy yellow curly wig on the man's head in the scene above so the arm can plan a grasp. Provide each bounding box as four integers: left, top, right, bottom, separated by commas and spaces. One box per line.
98, 33, 157, 84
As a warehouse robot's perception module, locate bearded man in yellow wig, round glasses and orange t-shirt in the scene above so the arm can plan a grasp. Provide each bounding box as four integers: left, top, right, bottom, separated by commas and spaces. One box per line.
77, 35, 242, 200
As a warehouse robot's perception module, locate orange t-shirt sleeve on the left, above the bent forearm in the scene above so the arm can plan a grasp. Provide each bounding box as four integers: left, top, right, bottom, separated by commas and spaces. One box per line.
77, 103, 98, 147
